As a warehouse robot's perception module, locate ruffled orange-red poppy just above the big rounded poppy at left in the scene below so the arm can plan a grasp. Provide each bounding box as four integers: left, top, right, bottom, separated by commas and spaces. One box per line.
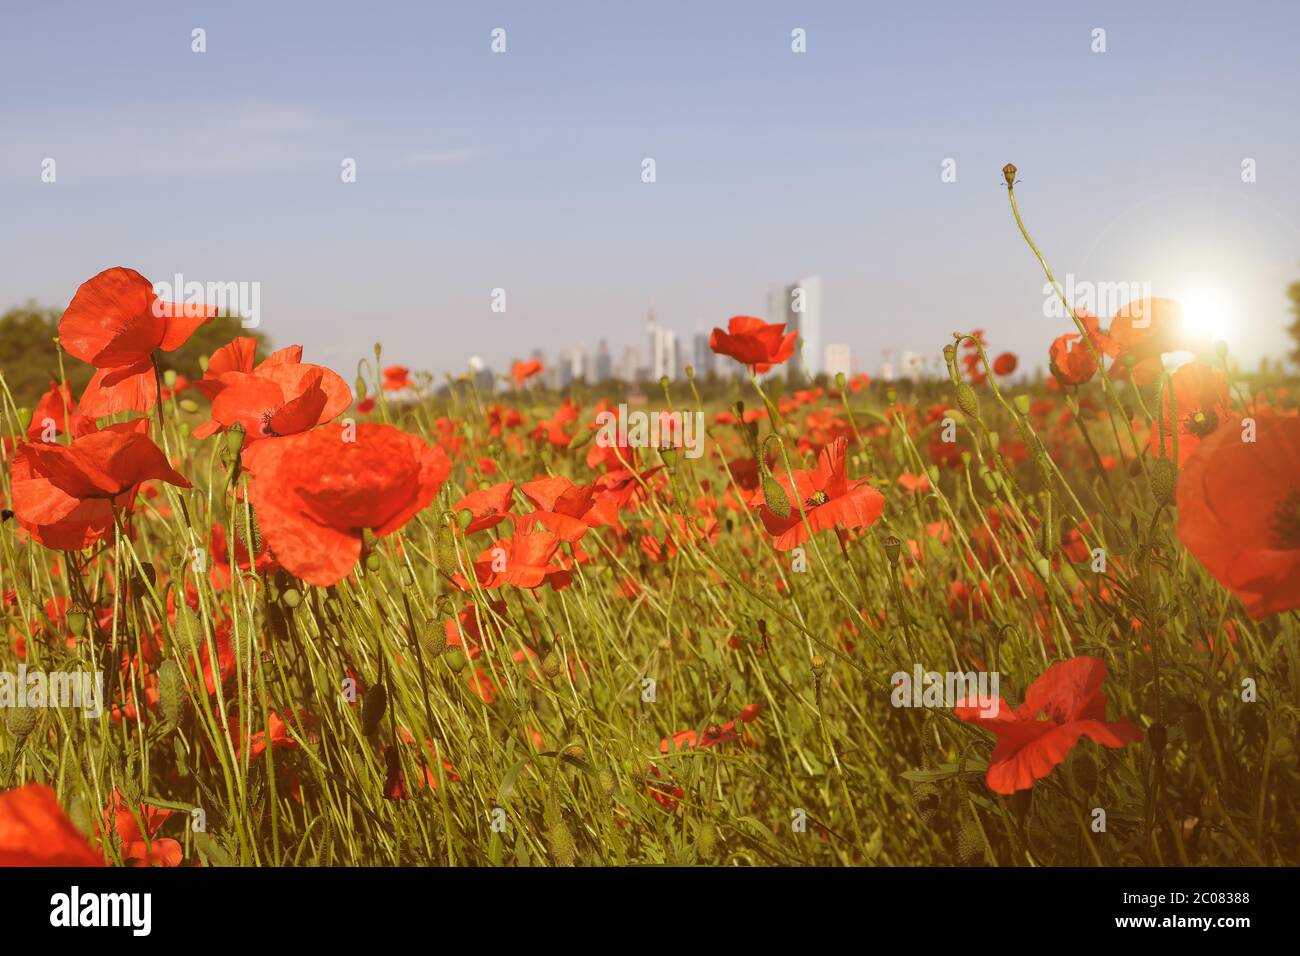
194, 339, 352, 441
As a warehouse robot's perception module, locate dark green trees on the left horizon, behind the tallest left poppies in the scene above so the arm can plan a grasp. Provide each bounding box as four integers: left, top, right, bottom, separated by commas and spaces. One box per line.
0, 302, 270, 407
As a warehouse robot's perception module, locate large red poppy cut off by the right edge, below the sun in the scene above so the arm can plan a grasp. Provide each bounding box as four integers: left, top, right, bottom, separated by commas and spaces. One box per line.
1178, 415, 1300, 620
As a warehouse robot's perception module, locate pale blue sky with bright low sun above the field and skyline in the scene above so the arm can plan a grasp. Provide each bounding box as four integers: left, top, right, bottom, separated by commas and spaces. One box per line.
0, 0, 1300, 377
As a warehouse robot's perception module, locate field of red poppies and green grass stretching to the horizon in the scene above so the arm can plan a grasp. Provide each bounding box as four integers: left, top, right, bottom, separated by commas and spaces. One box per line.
0, 166, 1300, 866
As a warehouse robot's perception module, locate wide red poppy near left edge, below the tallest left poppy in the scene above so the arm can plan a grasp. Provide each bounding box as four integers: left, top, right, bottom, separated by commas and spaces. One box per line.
13, 419, 190, 551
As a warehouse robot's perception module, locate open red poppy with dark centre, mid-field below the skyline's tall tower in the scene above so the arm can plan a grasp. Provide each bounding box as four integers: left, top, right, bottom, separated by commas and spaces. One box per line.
758, 438, 885, 551
